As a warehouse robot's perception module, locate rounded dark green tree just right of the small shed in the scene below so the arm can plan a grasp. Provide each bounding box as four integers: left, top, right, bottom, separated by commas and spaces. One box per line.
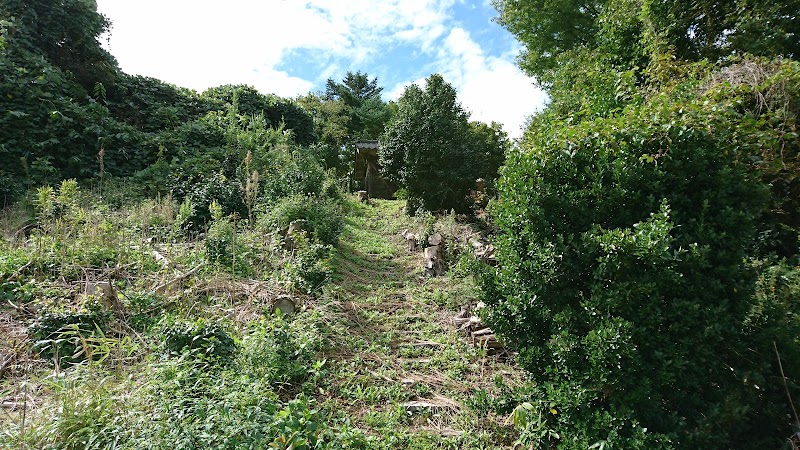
379, 74, 507, 212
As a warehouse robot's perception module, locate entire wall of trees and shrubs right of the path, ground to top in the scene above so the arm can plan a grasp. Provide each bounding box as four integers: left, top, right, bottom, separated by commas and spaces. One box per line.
484, 0, 800, 449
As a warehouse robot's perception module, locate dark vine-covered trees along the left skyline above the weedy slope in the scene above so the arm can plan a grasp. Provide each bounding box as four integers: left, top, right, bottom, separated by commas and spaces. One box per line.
0, 0, 318, 204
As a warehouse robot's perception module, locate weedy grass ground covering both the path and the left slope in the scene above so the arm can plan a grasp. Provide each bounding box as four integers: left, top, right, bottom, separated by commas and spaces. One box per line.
0, 198, 524, 450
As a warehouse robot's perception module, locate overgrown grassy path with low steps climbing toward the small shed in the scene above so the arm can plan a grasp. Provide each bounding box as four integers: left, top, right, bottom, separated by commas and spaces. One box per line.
315, 200, 521, 448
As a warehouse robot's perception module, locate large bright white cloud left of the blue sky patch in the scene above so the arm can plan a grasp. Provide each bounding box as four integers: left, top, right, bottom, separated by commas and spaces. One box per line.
98, 0, 453, 94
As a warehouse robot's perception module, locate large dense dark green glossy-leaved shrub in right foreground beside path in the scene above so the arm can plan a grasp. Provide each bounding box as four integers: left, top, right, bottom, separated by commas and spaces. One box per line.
484, 83, 787, 449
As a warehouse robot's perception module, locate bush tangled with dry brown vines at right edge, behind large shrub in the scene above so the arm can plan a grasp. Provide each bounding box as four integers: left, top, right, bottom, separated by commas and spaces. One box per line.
703, 58, 800, 258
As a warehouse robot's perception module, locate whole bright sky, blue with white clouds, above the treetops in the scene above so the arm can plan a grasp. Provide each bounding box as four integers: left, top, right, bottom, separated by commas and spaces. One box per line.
92, 0, 546, 136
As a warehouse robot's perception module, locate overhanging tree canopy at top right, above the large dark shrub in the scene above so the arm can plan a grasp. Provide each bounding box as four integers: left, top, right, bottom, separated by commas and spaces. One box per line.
493, 0, 800, 86
